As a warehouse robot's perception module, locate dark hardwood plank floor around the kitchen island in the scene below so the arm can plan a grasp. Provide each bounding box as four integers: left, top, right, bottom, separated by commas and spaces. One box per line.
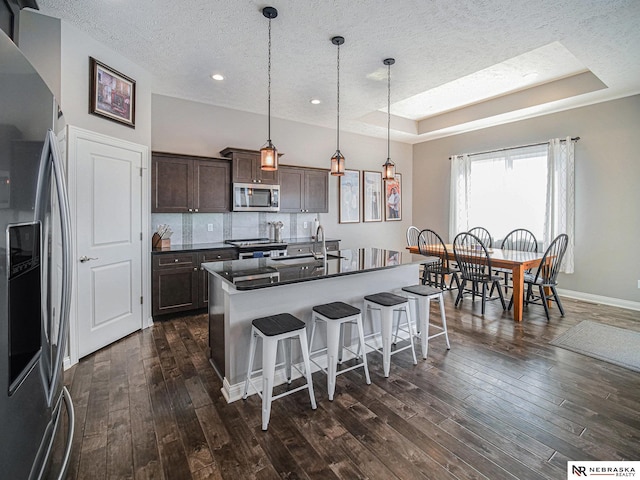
65, 293, 640, 480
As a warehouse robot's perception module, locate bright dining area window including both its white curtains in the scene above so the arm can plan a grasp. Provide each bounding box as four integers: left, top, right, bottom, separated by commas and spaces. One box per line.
449, 137, 580, 273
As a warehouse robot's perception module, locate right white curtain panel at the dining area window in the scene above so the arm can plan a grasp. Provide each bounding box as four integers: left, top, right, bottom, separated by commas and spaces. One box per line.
544, 137, 575, 273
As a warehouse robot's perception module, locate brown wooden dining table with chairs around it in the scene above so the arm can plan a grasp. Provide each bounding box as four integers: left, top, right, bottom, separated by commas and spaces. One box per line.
407, 244, 544, 322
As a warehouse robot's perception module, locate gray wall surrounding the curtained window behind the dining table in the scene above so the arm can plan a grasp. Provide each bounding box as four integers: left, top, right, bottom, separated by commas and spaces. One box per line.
413, 95, 640, 302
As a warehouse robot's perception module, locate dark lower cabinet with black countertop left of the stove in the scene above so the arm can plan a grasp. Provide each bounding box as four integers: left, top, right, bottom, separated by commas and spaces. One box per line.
151, 248, 238, 316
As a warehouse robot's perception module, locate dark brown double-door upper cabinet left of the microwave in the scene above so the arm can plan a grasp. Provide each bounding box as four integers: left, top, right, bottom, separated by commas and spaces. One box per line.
151, 152, 231, 213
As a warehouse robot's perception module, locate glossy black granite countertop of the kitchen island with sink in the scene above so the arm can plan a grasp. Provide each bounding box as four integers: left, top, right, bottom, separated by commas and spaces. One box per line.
202, 248, 418, 290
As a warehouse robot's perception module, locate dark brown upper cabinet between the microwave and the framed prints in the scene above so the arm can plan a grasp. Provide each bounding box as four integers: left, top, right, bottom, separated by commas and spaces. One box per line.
280, 165, 329, 213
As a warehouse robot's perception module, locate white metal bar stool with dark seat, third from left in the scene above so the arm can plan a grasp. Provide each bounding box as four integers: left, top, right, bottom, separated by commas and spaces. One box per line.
364, 292, 418, 377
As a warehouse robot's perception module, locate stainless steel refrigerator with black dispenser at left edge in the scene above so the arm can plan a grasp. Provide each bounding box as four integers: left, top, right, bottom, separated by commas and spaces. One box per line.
0, 31, 73, 480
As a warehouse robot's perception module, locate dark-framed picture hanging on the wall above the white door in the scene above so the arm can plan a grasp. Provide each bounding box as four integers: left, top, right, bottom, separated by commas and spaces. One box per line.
89, 57, 136, 128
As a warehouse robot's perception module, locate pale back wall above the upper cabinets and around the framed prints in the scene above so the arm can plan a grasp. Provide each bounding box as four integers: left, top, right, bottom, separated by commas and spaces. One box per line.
151, 95, 412, 249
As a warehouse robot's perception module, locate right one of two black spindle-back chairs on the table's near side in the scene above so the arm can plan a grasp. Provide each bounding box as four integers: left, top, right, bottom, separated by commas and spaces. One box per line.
453, 232, 507, 315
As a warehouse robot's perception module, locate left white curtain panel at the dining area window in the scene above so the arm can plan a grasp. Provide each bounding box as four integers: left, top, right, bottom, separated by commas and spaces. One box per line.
449, 154, 471, 242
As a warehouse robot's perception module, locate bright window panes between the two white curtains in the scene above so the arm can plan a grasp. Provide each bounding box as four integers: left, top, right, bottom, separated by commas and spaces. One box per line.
468, 144, 547, 245
